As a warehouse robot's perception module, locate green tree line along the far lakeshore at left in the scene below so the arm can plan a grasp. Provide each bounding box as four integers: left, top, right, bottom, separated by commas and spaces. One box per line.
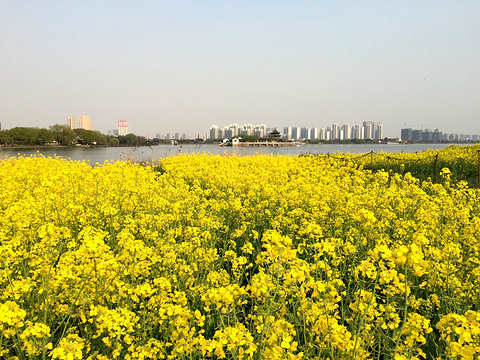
0, 124, 152, 146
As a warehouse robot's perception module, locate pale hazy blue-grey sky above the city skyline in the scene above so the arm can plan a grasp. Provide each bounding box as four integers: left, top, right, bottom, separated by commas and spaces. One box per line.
0, 0, 480, 137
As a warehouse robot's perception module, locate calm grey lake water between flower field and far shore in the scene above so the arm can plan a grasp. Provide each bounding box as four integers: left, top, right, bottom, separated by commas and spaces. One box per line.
0, 144, 466, 164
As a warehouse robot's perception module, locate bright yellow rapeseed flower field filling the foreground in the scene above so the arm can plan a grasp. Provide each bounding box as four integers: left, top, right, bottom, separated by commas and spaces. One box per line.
0, 148, 480, 360
